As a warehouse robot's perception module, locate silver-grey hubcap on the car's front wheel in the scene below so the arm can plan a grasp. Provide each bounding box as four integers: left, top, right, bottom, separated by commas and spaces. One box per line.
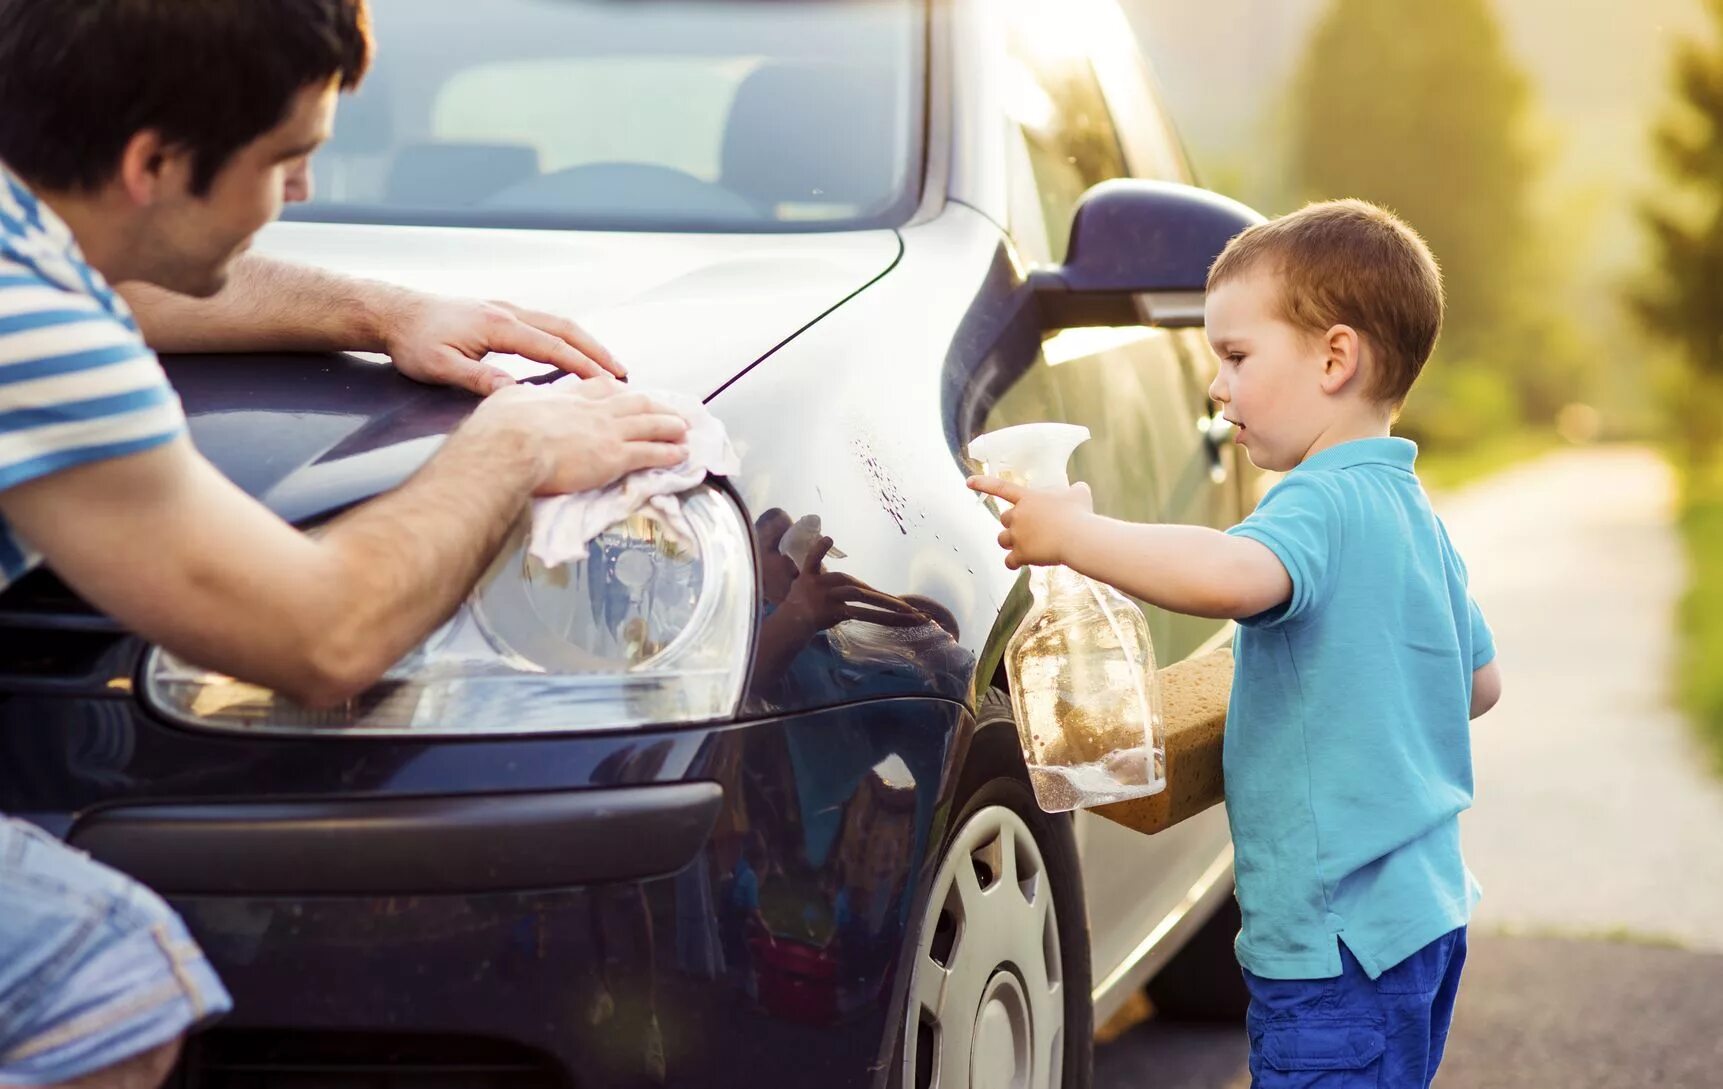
903, 806, 1065, 1089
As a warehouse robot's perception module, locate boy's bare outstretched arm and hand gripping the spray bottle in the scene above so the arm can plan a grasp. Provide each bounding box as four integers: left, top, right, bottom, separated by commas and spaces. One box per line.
970, 477, 1292, 620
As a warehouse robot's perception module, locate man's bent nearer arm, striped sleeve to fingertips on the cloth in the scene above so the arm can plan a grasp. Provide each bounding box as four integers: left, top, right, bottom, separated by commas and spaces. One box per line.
0, 386, 686, 706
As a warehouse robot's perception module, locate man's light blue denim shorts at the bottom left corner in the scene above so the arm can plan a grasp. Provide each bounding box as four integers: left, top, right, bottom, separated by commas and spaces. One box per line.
0, 817, 233, 1086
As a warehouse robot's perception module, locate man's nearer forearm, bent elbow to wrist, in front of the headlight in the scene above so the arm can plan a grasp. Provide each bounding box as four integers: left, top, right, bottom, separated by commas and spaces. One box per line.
303, 416, 543, 700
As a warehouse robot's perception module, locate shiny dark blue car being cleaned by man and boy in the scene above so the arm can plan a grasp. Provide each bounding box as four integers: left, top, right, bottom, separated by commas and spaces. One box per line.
0, 0, 1261, 1089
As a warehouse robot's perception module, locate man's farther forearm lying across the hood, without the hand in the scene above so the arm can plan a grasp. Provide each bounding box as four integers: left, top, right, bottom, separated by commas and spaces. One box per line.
119, 253, 403, 352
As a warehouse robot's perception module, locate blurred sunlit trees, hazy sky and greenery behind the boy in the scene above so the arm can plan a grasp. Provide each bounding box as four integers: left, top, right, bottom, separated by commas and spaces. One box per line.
1123, 0, 1723, 767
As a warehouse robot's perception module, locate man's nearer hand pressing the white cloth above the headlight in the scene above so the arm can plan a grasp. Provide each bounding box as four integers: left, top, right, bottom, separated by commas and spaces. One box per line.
472, 376, 687, 495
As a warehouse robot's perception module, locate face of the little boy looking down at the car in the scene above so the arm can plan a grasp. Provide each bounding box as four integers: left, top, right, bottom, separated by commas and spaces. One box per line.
1203, 271, 1334, 472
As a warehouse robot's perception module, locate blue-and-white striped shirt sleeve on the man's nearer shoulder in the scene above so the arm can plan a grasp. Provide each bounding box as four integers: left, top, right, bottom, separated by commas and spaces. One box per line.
0, 273, 184, 491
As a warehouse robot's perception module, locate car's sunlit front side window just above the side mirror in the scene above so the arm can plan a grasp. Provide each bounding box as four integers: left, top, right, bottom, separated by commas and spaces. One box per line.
1005, 19, 1130, 264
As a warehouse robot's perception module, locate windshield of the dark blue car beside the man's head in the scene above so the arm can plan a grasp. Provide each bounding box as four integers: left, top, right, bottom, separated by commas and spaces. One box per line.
288, 0, 925, 231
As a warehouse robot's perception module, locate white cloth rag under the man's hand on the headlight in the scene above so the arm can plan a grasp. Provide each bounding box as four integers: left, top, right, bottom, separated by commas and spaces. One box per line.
532, 376, 741, 567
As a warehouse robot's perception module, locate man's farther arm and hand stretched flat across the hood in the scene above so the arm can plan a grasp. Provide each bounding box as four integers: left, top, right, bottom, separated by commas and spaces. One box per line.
119, 253, 625, 395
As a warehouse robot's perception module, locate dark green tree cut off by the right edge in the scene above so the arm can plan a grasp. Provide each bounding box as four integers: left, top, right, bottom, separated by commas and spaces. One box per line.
1632, 0, 1723, 465
